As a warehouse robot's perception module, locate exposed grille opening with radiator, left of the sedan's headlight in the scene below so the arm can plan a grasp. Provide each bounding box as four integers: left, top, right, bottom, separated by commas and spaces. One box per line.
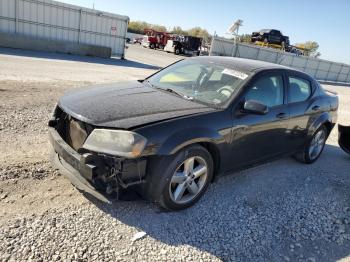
56, 109, 94, 151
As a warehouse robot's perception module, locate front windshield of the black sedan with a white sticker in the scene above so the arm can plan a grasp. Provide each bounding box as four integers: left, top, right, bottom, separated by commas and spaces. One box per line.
148, 59, 248, 106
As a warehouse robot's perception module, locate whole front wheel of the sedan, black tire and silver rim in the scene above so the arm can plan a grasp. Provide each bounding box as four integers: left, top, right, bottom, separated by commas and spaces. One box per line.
147, 145, 214, 210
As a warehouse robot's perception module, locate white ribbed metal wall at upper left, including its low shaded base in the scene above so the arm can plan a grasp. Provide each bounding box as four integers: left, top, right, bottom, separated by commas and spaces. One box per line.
0, 0, 129, 58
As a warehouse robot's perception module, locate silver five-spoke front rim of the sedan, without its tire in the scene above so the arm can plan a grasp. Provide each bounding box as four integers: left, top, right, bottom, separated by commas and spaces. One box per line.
169, 156, 208, 204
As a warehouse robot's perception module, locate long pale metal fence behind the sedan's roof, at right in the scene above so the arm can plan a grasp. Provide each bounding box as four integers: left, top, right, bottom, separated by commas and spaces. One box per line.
210, 37, 350, 83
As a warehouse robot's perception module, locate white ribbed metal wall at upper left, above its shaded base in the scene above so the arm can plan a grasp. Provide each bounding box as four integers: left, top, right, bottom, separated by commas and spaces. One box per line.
0, 0, 129, 56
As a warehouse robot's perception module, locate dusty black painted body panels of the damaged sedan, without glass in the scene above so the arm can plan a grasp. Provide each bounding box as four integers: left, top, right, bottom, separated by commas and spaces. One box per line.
50, 57, 338, 204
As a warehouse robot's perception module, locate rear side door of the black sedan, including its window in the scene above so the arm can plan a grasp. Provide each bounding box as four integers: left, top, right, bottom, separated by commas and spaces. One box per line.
286, 72, 322, 150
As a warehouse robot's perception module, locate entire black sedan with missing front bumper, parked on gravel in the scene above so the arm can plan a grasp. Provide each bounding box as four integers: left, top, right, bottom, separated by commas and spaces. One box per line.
49, 57, 338, 210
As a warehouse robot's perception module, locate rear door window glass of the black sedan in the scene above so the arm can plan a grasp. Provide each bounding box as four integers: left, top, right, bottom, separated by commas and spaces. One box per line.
289, 77, 311, 103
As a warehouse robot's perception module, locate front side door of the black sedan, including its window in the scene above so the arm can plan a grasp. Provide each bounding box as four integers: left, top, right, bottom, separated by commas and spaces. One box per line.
231, 71, 289, 167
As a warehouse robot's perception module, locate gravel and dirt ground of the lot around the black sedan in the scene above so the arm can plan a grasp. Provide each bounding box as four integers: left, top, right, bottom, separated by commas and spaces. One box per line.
0, 46, 350, 262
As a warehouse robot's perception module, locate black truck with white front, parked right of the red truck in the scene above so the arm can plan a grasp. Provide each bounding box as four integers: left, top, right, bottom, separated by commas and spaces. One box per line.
164, 35, 202, 56
